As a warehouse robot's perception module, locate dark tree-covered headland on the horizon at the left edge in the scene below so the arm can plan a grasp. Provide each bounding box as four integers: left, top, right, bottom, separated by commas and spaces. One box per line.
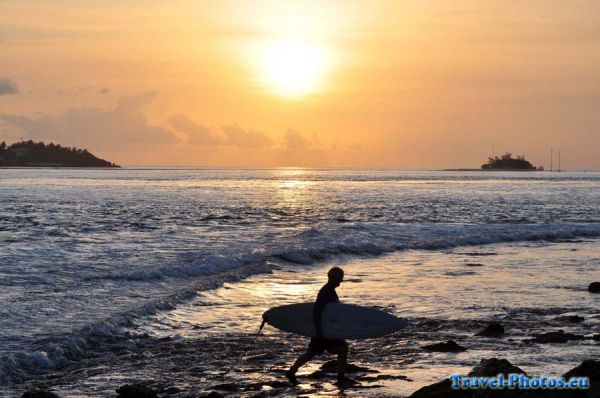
0, 140, 120, 167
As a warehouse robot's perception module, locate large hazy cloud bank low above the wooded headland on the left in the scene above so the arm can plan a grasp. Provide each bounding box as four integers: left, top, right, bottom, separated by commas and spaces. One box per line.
0, 92, 178, 150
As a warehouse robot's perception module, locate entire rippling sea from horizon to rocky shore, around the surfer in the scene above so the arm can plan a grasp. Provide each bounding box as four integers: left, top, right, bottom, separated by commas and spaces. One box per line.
0, 168, 600, 397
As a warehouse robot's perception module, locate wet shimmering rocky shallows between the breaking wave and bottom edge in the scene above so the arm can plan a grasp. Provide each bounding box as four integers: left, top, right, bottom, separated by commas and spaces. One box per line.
7, 240, 600, 398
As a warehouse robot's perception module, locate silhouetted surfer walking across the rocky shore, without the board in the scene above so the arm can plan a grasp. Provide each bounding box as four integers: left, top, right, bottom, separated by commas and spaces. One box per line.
285, 267, 356, 385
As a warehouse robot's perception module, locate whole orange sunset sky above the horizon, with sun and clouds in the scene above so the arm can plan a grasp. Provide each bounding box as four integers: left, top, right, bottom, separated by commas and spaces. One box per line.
0, 0, 600, 169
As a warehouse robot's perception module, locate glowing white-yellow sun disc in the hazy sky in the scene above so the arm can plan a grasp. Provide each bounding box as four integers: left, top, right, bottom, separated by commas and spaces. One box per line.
260, 39, 329, 98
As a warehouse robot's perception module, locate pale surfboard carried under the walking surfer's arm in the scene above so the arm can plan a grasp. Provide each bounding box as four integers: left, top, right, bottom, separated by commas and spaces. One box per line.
263, 303, 408, 339
